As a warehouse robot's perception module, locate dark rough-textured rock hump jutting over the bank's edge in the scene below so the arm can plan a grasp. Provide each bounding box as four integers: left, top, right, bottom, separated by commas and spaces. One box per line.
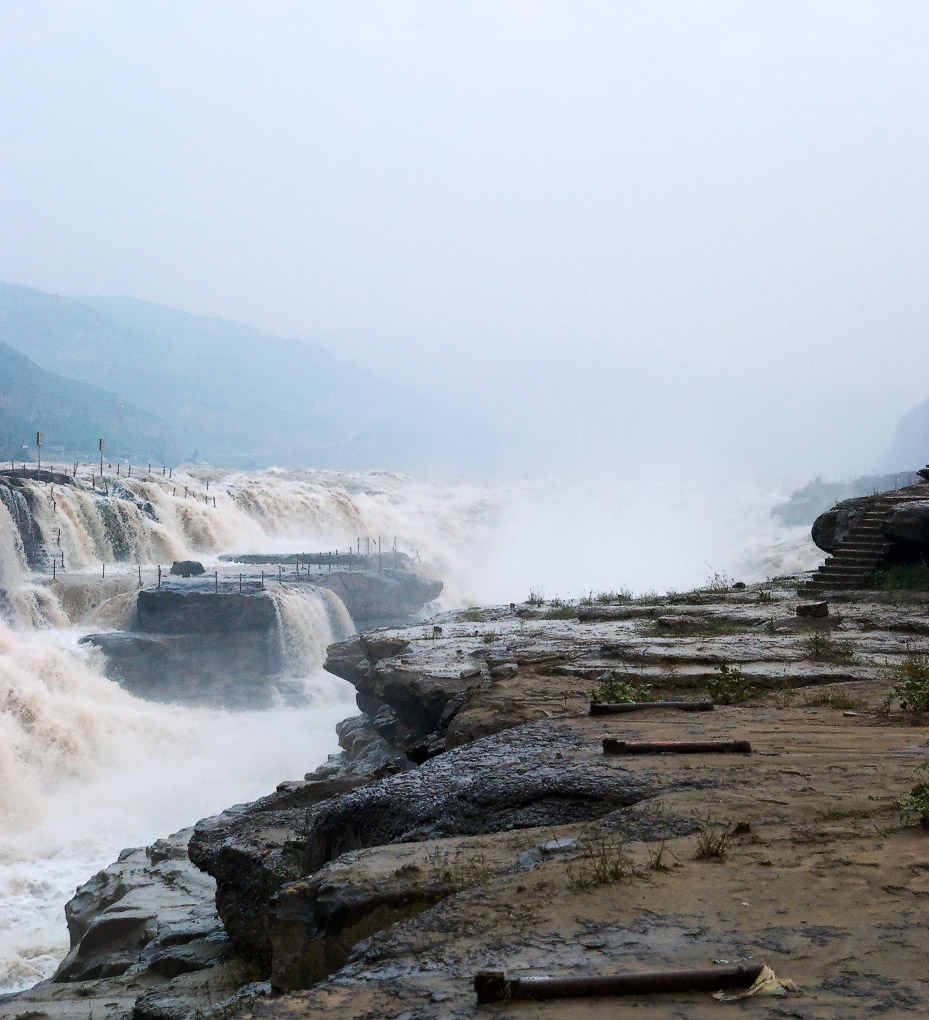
190, 723, 654, 971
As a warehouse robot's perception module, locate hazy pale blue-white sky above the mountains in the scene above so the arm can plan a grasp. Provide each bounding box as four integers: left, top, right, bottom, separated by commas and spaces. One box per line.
0, 0, 929, 475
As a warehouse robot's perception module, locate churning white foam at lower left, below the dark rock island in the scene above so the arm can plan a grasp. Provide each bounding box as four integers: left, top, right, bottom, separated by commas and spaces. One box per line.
0, 624, 354, 989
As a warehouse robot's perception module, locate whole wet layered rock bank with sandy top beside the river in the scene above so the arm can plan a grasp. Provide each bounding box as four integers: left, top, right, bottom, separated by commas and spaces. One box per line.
0, 578, 929, 1020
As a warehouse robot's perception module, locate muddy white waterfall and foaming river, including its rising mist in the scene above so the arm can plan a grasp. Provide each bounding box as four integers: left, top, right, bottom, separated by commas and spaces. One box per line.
0, 468, 818, 988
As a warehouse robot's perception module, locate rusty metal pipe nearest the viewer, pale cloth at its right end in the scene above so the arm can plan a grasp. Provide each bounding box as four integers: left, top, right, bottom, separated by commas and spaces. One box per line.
474, 963, 765, 1004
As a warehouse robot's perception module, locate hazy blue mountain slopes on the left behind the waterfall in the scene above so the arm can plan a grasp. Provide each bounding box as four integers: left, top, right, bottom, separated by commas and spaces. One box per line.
0, 284, 492, 470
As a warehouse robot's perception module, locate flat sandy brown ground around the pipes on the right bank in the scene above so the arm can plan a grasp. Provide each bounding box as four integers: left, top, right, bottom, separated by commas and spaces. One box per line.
241, 682, 929, 1018
